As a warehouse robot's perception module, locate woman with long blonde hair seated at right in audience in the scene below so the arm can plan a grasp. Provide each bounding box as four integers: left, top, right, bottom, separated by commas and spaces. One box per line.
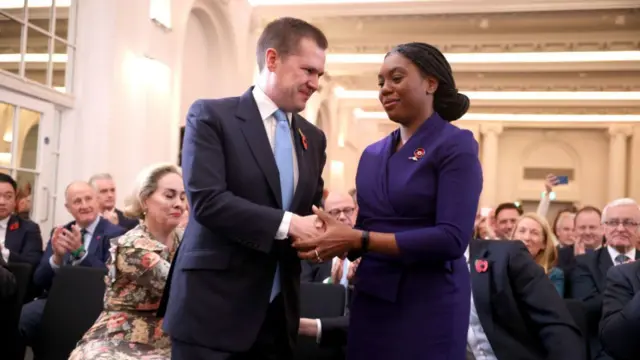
511, 213, 564, 297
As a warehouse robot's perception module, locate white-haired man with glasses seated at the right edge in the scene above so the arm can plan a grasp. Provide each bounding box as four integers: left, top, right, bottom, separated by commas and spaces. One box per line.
571, 199, 640, 360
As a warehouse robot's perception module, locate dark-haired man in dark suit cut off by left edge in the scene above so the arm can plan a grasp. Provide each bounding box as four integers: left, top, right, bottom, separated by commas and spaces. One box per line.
0, 173, 42, 268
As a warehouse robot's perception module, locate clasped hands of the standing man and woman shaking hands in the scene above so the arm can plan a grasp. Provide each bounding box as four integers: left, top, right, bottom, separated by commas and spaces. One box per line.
289, 206, 361, 263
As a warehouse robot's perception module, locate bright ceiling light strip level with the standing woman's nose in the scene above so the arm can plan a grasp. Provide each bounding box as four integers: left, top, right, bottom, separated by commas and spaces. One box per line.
334, 87, 640, 101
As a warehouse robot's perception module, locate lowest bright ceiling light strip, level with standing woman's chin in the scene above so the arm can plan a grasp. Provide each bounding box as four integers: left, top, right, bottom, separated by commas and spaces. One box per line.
353, 109, 640, 123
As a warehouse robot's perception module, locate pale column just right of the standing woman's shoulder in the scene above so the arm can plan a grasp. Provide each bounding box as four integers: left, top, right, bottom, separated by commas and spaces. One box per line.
479, 124, 503, 207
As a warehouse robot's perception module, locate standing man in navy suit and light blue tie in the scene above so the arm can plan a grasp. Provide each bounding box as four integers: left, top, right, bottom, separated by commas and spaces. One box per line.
159, 18, 328, 360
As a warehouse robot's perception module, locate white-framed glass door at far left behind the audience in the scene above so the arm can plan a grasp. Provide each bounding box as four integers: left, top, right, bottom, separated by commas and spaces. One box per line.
0, 88, 58, 242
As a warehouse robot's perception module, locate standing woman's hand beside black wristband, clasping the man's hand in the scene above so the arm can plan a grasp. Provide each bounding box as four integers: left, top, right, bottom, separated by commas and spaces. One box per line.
292, 206, 361, 262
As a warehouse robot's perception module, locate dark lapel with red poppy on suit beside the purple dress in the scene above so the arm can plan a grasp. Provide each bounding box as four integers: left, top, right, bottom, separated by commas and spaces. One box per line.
469, 240, 493, 339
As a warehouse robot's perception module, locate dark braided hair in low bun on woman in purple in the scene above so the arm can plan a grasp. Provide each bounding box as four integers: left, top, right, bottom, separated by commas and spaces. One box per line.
387, 42, 469, 121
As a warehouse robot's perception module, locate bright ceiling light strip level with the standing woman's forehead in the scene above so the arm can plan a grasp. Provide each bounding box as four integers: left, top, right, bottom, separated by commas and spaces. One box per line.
327, 51, 640, 64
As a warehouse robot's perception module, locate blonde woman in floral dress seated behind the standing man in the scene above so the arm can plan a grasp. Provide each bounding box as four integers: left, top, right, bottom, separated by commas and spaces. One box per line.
69, 165, 186, 360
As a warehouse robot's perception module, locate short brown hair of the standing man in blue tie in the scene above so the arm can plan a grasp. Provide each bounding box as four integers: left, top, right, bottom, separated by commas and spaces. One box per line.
256, 17, 329, 71
